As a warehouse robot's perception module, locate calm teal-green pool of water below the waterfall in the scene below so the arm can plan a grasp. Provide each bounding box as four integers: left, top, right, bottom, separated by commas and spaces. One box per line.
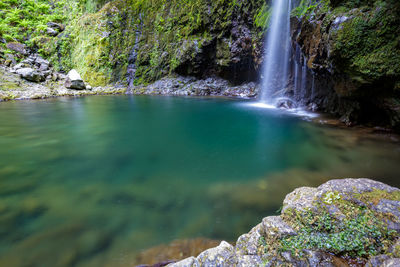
0, 96, 400, 266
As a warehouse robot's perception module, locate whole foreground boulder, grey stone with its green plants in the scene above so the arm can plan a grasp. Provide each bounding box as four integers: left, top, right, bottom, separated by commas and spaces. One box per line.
168, 179, 400, 267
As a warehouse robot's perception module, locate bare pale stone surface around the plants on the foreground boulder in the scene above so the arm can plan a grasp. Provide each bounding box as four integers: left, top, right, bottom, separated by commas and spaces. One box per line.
168, 179, 400, 267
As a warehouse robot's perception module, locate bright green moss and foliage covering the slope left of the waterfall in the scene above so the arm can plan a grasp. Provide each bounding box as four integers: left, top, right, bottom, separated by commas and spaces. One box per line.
0, 0, 266, 85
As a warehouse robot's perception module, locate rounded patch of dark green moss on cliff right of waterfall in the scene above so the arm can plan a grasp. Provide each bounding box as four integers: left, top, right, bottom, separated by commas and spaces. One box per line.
333, 1, 400, 80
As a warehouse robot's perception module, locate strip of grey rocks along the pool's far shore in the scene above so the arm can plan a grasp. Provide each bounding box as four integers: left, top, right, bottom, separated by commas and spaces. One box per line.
0, 66, 259, 102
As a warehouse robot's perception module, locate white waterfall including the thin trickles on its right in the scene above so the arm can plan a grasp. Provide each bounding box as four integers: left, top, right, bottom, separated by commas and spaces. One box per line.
259, 0, 311, 109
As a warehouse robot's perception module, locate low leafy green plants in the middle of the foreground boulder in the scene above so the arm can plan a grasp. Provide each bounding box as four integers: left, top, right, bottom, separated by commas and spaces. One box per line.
281, 205, 395, 258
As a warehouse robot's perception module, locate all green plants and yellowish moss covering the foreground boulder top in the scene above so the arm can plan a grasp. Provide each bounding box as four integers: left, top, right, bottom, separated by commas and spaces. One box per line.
259, 190, 400, 264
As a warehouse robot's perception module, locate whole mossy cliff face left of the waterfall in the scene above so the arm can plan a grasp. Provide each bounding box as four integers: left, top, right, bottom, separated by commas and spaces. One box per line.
31, 0, 268, 86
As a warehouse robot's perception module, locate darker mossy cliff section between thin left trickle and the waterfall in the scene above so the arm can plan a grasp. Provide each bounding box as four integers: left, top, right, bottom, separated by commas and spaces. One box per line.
136, 0, 264, 83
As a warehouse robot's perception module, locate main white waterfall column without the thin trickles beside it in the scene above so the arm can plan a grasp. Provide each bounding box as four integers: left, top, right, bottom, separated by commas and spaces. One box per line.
260, 0, 291, 104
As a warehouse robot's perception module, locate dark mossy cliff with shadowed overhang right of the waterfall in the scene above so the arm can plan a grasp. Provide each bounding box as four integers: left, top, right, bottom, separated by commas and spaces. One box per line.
292, 0, 400, 129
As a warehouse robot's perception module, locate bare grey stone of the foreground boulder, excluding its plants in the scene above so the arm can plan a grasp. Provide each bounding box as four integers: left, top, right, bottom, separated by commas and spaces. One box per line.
164, 179, 400, 267
